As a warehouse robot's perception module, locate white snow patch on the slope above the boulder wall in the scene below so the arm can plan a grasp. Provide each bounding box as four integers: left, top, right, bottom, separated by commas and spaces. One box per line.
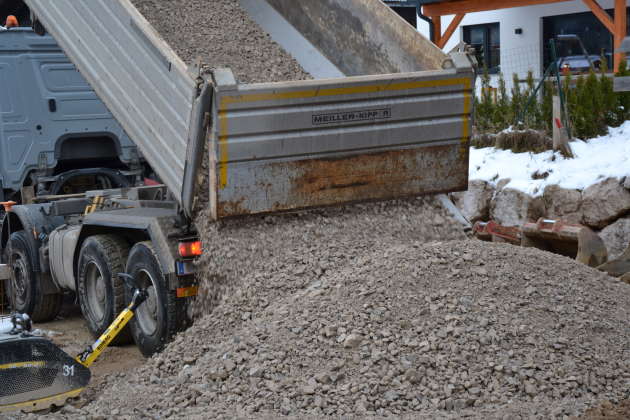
470, 121, 630, 196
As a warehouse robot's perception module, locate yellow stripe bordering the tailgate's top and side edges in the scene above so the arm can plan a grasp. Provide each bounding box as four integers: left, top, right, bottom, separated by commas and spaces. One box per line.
218, 77, 471, 189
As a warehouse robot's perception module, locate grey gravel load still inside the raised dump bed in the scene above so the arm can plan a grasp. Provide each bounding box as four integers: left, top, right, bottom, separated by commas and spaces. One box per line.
132, 0, 311, 83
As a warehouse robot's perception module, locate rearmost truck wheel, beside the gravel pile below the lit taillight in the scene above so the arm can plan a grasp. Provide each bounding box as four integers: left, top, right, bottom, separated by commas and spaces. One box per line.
125, 242, 178, 357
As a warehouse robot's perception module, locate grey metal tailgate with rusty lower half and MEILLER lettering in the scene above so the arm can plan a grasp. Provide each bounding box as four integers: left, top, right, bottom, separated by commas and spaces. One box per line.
210, 68, 474, 219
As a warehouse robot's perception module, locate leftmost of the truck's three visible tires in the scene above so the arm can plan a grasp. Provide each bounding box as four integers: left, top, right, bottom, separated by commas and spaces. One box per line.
5, 230, 63, 322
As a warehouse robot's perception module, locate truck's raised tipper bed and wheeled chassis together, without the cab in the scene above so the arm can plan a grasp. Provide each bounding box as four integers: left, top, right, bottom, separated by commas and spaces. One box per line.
0, 0, 475, 355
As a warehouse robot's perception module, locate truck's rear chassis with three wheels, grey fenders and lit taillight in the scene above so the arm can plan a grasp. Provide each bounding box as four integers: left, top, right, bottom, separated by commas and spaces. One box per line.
0, 186, 200, 355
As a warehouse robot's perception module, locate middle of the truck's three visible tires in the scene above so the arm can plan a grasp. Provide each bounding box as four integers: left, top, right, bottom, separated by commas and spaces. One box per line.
77, 235, 131, 345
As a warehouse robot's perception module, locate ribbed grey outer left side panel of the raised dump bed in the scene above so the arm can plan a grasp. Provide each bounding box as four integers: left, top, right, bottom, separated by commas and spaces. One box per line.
26, 0, 197, 207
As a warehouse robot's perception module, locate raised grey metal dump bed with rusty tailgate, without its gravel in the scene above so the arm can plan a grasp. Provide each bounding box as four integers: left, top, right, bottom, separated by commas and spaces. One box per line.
27, 0, 474, 218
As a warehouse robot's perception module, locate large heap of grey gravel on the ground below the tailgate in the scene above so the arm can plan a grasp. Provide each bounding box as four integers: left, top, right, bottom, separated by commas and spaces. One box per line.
48, 199, 630, 419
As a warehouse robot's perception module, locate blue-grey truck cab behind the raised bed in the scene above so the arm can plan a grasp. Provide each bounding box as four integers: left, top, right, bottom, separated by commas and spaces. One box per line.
0, 15, 141, 202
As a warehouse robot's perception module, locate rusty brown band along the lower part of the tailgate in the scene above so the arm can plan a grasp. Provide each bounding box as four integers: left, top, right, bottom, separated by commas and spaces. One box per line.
217, 145, 468, 218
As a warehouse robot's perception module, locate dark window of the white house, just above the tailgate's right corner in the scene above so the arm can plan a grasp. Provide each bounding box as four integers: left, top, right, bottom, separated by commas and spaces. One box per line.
463, 23, 501, 73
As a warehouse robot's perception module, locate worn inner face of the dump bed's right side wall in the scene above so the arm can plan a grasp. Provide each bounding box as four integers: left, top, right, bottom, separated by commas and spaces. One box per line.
239, 0, 447, 79
